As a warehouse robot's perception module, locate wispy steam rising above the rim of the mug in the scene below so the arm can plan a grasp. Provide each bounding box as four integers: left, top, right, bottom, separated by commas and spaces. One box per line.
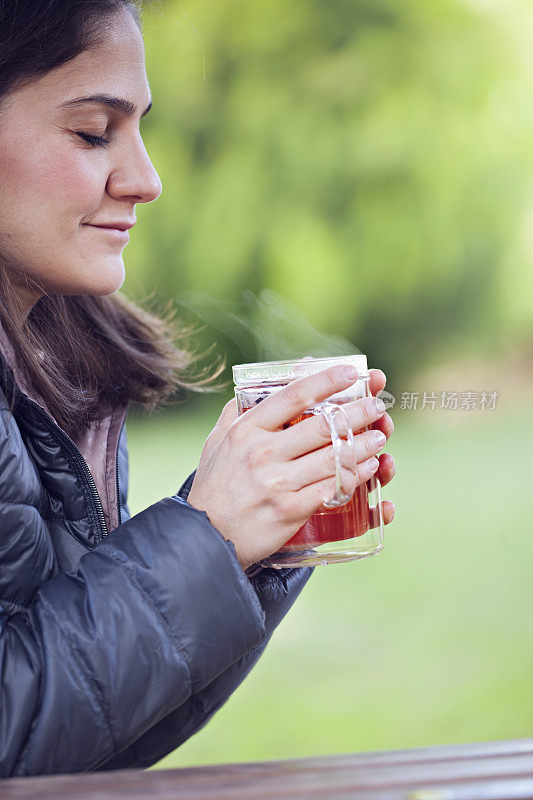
177, 289, 360, 362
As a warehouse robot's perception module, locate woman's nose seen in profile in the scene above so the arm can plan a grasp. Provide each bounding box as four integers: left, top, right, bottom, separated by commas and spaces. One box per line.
107, 135, 163, 203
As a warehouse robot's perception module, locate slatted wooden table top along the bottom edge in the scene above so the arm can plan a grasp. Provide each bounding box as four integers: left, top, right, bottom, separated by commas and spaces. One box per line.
0, 739, 533, 800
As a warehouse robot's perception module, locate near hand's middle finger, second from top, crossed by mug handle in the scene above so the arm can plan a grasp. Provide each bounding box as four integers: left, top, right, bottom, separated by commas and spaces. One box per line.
278, 397, 385, 459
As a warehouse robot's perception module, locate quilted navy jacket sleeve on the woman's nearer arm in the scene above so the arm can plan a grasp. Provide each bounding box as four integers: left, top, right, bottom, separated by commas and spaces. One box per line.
0, 496, 267, 777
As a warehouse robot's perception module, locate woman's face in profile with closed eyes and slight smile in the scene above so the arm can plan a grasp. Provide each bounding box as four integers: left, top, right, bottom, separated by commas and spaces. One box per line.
0, 10, 161, 318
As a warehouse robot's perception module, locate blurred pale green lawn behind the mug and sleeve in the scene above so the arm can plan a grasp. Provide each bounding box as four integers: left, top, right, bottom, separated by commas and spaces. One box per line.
122, 400, 533, 767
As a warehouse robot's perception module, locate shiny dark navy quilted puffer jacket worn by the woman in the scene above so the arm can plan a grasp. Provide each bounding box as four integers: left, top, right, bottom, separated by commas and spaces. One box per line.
0, 354, 311, 777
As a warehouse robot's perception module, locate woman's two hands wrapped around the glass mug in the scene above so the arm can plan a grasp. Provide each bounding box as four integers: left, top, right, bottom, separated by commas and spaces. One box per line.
188, 367, 394, 569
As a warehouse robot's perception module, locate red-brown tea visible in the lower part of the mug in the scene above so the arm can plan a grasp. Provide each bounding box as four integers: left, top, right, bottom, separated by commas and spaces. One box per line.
242, 406, 371, 553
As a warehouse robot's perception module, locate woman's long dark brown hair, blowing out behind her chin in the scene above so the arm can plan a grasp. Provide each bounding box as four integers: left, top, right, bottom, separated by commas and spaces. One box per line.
0, 0, 208, 437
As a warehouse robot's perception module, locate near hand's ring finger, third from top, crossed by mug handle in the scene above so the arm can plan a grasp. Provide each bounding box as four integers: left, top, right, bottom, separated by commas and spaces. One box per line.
287, 431, 386, 489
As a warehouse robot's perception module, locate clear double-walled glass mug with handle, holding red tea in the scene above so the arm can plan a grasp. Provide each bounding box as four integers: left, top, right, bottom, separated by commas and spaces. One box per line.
233, 355, 383, 569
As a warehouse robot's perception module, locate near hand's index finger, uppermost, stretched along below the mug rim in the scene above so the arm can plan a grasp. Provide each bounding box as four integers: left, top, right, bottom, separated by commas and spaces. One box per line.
245, 365, 357, 431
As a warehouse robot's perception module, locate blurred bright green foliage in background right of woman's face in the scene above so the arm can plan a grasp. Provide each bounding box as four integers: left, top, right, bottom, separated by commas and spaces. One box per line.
125, 0, 533, 382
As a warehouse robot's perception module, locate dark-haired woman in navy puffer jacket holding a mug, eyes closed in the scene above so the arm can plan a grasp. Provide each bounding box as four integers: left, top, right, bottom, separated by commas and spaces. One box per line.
0, 0, 394, 776
